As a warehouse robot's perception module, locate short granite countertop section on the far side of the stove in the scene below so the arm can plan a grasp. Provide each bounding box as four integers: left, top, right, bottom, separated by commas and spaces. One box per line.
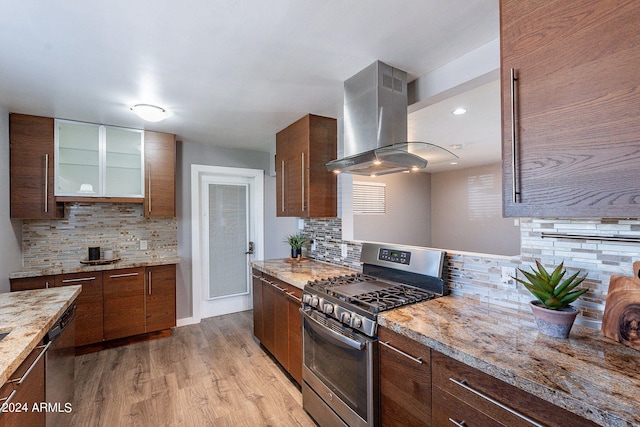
251, 258, 360, 289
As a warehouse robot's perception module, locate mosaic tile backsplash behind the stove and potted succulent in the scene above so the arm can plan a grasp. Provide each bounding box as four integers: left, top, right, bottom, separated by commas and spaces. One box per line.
301, 218, 640, 329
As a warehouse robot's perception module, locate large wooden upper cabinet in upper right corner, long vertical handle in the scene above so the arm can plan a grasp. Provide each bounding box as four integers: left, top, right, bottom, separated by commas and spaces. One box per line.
500, 0, 640, 218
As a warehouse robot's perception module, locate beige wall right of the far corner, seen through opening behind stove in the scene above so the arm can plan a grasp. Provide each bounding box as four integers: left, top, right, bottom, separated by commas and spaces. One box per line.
431, 163, 520, 255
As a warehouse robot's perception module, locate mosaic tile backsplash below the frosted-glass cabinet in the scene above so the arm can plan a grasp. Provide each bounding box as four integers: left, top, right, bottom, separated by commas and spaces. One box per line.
22, 203, 178, 269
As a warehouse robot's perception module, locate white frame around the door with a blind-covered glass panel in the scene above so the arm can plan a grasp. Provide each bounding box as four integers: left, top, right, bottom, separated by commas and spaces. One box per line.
191, 165, 264, 323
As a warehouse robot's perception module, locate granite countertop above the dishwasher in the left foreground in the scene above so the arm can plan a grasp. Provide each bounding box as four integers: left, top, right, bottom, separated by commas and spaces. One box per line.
0, 286, 82, 384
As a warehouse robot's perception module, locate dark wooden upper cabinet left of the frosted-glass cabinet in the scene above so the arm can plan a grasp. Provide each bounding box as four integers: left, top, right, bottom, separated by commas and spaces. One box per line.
9, 114, 64, 219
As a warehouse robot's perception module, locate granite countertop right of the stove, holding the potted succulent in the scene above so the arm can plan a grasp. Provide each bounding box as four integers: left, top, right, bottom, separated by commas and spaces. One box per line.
378, 295, 640, 427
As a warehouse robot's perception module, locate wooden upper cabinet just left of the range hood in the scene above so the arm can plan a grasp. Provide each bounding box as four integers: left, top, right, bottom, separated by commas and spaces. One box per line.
276, 114, 338, 218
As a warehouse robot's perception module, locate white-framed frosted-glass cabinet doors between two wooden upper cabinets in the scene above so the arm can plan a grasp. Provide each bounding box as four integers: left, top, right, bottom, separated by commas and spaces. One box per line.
55, 120, 144, 197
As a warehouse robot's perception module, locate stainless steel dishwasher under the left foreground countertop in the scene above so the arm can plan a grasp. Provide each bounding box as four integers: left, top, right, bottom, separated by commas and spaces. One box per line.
44, 302, 76, 426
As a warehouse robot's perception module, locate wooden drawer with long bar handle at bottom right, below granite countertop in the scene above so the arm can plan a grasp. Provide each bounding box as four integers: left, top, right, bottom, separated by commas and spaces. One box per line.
431, 351, 596, 427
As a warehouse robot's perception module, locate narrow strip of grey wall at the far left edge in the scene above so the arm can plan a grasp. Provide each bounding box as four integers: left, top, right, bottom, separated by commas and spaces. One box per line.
0, 109, 22, 293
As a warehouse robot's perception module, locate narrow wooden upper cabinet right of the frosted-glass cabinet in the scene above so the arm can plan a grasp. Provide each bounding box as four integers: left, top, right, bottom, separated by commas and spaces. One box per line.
144, 131, 176, 218
